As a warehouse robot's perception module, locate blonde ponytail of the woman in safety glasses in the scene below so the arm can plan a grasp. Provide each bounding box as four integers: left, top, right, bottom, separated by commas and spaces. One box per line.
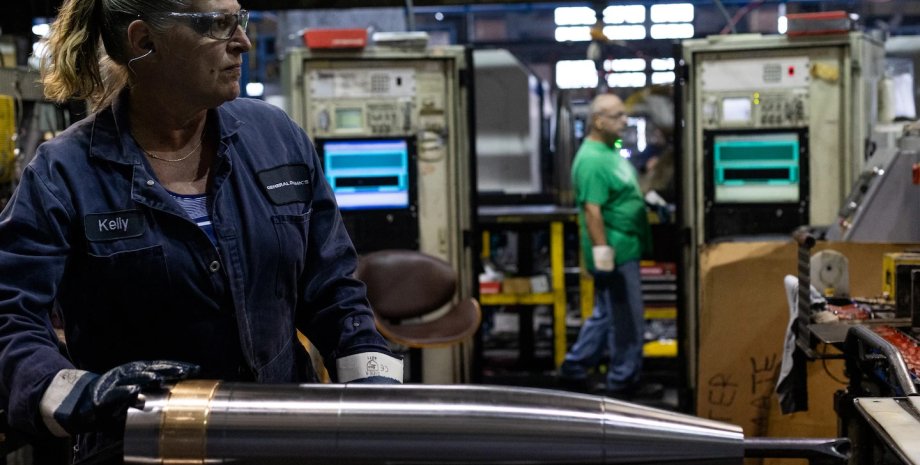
42, 0, 105, 107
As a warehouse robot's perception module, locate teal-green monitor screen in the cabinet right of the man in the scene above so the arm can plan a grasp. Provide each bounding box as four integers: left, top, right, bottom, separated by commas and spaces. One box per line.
712, 132, 800, 203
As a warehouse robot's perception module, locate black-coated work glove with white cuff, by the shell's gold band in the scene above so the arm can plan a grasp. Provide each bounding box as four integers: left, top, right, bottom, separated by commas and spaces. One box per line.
41, 360, 199, 436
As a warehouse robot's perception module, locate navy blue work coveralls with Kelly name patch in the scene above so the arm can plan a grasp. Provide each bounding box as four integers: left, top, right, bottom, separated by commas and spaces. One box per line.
0, 93, 389, 442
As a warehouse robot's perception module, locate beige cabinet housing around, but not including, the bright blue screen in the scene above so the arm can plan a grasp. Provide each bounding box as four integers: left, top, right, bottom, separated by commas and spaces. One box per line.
282, 46, 474, 383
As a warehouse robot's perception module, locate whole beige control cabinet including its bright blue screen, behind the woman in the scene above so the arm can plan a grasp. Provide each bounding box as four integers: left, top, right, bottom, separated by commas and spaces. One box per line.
282, 46, 476, 384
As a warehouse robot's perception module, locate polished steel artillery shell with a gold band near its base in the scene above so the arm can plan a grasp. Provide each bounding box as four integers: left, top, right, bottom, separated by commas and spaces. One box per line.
125, 381, 744, 465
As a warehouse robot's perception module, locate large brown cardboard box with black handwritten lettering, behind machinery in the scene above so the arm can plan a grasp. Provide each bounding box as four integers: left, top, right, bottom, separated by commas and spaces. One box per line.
691, 241, 916, 442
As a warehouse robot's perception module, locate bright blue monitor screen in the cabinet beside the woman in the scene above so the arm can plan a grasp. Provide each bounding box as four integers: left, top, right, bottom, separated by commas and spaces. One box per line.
317, 139, 411, 210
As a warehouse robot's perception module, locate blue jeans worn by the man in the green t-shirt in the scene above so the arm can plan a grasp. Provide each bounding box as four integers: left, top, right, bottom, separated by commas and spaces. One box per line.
560, 260, 645, 390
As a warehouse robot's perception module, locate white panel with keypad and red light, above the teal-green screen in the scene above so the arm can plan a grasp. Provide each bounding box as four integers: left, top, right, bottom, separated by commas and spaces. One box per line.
700, 57, 810, 92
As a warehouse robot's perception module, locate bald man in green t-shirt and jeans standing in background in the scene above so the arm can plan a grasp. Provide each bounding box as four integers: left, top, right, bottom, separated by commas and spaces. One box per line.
560, 94, 650, 396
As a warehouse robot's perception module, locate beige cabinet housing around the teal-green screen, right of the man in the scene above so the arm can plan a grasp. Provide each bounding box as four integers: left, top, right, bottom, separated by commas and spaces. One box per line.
680, 32, 884, 387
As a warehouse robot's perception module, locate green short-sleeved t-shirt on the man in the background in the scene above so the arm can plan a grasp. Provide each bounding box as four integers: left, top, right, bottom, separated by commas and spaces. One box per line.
572, 139, 650, 270
